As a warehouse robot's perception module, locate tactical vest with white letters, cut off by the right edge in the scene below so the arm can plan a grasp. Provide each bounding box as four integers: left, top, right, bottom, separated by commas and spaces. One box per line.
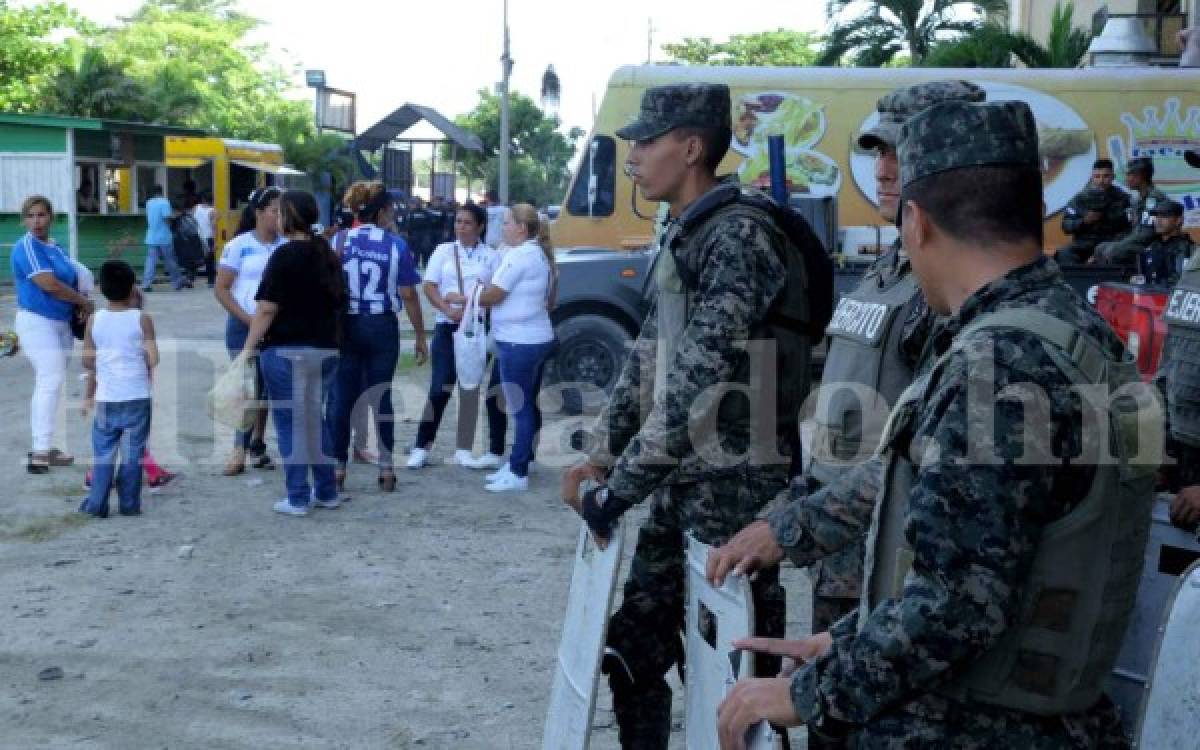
1163, 259, 1200, 448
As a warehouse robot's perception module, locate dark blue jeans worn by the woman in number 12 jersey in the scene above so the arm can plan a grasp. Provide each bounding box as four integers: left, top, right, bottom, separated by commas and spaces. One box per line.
330, 312, 400, 467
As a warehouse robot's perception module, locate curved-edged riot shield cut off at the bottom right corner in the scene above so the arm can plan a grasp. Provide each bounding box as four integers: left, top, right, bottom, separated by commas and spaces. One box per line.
1134, 562, 1200, 750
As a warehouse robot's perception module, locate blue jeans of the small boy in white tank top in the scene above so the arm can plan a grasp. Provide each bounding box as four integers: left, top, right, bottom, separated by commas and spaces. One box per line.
79, 398, 151, 517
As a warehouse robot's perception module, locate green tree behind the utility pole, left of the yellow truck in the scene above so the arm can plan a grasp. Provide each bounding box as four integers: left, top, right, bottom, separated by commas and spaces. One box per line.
444, 89, 583, 205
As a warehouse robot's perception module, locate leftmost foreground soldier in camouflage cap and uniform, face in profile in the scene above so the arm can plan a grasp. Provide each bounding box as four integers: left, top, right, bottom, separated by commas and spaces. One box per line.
563, 84, 810, 749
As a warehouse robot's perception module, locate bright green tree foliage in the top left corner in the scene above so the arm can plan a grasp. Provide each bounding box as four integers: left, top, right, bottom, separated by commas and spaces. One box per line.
0, 0, 89, 113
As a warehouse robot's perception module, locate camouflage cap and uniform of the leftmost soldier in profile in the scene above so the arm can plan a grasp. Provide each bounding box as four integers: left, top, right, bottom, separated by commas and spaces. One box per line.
589, 84, 790, 749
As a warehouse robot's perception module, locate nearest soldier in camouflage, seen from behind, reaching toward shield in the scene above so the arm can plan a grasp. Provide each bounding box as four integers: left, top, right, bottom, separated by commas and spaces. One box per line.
710, 102, 1162, 750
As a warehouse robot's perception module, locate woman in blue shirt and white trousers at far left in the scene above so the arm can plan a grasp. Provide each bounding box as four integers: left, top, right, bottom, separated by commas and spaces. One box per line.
12, 196, 94, 474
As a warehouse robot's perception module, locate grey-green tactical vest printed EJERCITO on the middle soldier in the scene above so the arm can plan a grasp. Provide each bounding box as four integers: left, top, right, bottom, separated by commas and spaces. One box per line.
809, 259, 918, 485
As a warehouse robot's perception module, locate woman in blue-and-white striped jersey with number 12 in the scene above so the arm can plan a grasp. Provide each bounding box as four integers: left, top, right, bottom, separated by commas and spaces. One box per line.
330, 182, 428, 492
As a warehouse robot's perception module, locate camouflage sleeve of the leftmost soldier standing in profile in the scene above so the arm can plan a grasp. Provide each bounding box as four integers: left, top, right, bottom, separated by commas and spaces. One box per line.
608, 217, 784, 503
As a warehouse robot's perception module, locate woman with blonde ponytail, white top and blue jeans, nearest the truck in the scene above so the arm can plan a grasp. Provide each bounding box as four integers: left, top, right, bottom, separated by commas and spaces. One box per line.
479, 203, 557, 492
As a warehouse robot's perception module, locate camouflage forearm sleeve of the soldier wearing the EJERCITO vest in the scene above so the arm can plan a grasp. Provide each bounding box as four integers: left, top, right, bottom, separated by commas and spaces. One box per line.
767, 456, 883, 568
